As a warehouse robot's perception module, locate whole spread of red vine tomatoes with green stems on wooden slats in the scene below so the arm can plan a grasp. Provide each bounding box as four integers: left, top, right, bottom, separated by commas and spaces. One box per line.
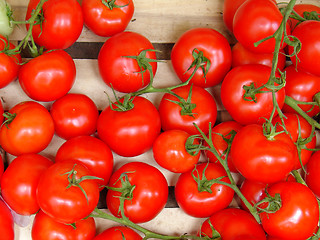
0, 0, 320, 240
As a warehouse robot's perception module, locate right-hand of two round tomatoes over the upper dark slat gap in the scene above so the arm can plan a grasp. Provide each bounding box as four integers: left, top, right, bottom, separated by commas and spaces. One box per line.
171, 28, 232, 88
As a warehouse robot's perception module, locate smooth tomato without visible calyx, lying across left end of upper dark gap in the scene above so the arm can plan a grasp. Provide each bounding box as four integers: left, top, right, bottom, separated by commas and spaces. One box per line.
19, 50, 76, 102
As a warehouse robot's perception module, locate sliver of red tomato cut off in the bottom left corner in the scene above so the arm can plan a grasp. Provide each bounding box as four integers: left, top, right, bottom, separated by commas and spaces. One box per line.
0, 200, 15, 240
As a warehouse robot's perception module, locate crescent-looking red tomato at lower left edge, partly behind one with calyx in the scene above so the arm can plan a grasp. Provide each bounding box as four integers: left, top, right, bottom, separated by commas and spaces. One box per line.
1, 153, 52, 215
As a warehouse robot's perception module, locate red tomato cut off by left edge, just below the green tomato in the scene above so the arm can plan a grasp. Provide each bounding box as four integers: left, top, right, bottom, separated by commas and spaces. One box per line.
0, 34, 22, 88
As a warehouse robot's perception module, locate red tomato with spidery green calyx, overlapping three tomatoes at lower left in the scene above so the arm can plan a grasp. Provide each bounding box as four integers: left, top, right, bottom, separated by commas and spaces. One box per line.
37, 161, 99, 224
